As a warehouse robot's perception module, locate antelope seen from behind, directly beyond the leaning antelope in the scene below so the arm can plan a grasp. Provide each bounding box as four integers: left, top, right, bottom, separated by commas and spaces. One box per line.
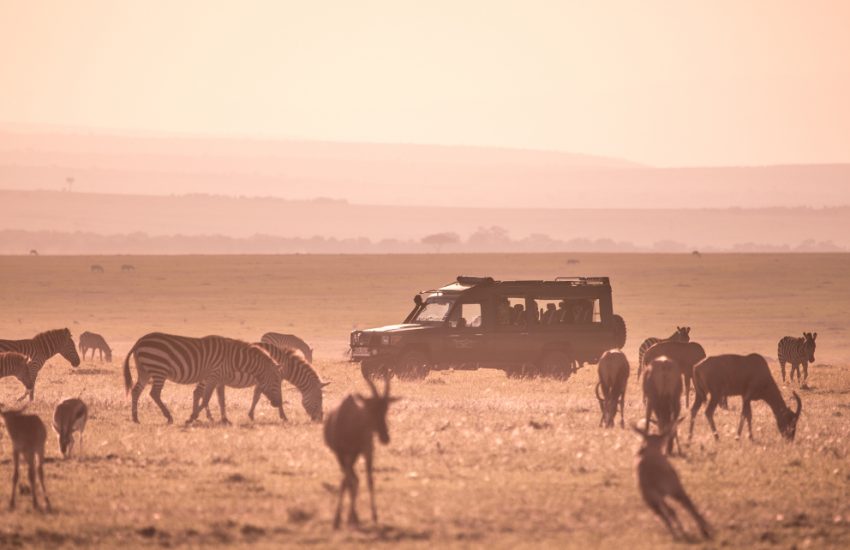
643, 356, 682, 454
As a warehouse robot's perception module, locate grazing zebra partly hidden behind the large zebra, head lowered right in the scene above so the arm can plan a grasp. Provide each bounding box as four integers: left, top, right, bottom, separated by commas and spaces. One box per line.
206, 342, 330, 422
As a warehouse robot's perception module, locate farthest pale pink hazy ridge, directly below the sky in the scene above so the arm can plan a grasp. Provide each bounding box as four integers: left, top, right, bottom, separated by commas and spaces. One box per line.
0, 129, 850, 209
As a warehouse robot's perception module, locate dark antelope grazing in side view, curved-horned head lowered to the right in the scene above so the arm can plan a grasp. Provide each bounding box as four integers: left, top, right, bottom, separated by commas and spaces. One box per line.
688, 353, 803, 441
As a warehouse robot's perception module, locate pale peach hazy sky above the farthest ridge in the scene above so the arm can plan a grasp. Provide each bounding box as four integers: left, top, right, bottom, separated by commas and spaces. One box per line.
0, 0, 850, 166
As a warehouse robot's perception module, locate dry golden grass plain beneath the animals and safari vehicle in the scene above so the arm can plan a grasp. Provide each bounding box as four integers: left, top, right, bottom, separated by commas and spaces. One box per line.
0, 254, 850, 548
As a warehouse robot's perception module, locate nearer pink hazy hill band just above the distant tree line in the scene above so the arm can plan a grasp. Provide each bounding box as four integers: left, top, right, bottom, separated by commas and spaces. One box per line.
0, 190, 850, 253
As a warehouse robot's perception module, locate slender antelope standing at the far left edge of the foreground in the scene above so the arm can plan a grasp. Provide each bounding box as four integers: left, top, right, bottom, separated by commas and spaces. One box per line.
0, 407, 50, 512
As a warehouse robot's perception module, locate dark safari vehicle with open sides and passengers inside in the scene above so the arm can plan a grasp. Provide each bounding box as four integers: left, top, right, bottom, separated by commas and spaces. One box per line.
351, 276, 626, 379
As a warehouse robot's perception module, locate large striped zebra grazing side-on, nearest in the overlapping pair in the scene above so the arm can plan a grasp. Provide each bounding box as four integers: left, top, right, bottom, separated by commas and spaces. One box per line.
124, 332, 284, 424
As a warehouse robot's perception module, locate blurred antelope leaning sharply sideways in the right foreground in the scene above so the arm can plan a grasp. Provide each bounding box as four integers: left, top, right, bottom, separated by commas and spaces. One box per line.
632, 419, 711, 539
